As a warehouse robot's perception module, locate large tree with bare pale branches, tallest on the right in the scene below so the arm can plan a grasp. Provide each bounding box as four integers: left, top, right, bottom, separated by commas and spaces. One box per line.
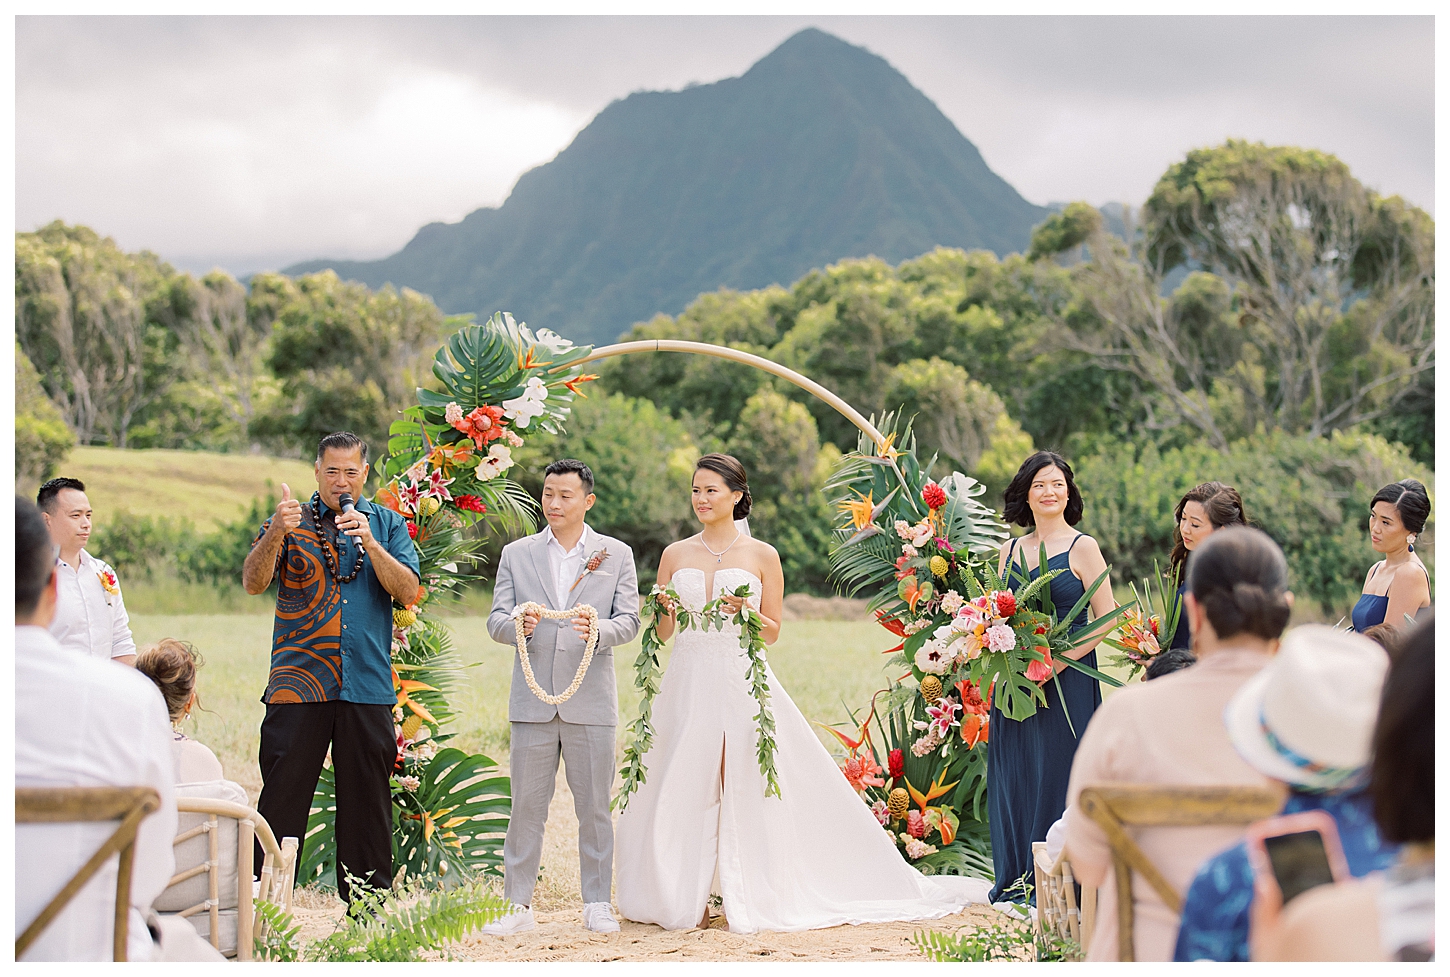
1059, 141, 1434, 449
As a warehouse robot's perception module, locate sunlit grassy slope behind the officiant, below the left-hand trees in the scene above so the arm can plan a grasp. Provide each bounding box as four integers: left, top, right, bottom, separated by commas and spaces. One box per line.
55, 448, 316, 531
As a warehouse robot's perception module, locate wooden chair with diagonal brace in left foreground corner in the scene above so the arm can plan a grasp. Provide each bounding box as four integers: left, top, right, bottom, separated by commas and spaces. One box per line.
15, 787, 161, 961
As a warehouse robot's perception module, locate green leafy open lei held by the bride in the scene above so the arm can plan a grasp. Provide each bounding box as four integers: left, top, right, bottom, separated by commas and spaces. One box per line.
610, 584, 780, 810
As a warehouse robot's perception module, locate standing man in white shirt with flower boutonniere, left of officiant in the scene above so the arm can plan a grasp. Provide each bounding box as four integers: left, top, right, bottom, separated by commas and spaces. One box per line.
35, 478, 136, 665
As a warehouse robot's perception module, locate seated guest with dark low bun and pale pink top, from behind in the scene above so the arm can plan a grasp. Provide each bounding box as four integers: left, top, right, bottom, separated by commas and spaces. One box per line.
1067, 526, 1293, 960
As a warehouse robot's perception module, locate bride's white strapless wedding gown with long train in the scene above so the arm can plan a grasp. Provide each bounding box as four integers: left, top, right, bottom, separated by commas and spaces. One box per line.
615, 567, 990, 934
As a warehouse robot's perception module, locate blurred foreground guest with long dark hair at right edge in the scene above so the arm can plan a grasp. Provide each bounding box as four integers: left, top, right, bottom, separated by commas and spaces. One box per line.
1250, 612, 1436, 961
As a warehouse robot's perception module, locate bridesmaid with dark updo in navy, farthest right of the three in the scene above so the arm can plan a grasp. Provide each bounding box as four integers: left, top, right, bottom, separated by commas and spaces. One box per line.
1350, 478, 1430, 632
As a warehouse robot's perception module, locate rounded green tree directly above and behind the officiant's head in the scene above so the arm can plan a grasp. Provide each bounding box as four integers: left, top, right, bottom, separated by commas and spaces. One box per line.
248, 271, 446, 457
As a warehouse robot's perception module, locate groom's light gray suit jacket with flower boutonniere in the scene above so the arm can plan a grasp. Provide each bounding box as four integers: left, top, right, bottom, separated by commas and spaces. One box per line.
489, 526, 639, 726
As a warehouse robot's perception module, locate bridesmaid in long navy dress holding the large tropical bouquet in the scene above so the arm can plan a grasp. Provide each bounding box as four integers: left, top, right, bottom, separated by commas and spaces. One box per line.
987, 451, 1115, 902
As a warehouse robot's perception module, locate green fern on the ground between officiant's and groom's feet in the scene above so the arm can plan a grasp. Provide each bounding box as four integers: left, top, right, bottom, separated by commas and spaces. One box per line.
303, 880, 509, 963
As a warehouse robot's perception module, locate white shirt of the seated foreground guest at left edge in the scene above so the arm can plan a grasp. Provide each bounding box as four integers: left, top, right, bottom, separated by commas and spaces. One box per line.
15, 626, 177, 961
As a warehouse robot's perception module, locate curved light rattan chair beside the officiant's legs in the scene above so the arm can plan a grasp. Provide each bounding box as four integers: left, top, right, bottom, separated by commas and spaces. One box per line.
157, 796, 297, 961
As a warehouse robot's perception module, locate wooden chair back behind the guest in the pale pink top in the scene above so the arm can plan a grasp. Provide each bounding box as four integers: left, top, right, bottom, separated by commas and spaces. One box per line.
1077, 784, 1283, 960
